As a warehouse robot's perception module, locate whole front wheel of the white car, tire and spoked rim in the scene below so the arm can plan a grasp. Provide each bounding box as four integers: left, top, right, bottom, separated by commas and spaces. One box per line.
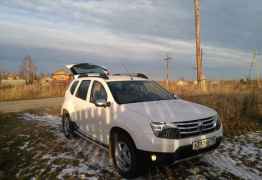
112, 133, 147, 178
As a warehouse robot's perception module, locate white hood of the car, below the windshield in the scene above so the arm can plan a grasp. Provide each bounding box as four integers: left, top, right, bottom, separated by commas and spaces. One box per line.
123, 99, 217, 123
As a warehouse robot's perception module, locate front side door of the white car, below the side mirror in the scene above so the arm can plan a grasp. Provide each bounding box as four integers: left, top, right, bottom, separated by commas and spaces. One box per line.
90, 81, 110, 144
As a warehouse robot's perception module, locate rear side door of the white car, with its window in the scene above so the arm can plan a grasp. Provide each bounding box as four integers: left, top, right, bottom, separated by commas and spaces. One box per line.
73, 80, 91, 135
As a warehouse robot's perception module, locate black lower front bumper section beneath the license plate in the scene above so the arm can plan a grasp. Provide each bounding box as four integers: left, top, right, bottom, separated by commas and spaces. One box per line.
142, 137, 222, 165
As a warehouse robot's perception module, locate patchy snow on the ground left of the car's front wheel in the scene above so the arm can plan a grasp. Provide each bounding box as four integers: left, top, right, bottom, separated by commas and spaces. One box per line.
21, 113, 117, 180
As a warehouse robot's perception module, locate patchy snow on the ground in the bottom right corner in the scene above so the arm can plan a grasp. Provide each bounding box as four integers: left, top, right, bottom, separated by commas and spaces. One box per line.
205, 132, 262, 180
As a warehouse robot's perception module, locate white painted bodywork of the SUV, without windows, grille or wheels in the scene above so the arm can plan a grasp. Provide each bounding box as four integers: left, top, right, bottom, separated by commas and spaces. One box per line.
62, 75, 223, 153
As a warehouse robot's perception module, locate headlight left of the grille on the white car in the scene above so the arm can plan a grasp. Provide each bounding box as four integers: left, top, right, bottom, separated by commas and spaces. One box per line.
151, 122, 179, 139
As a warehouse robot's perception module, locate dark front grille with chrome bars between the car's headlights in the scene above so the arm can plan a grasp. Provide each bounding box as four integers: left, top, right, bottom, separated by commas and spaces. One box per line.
173, 116, 217, 138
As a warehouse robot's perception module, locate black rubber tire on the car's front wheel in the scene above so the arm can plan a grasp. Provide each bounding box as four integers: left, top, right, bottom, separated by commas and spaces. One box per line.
111, 133, 148, 178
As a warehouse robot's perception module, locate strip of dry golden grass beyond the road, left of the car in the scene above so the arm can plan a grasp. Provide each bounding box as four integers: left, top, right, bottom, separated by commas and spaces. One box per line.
0, 84, 67, 101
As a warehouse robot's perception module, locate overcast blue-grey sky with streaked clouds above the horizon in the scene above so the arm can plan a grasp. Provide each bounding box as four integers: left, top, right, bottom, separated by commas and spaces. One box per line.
0, 0, 262, 79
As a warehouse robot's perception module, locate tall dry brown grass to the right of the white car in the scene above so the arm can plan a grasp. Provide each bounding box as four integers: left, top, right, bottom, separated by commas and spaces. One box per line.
162, 82, 262, 135
